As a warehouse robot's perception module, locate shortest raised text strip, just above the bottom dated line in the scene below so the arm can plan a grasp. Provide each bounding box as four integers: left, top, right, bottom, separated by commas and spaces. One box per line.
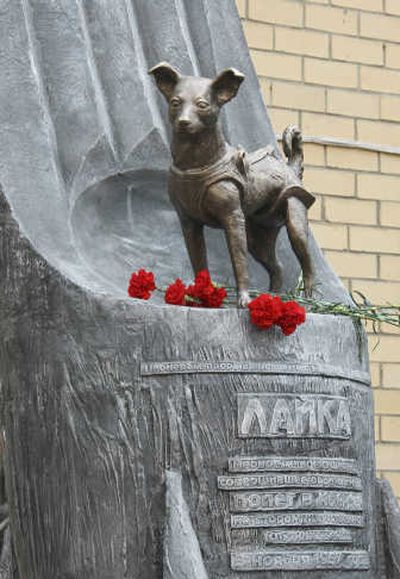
263, 529, 353, 545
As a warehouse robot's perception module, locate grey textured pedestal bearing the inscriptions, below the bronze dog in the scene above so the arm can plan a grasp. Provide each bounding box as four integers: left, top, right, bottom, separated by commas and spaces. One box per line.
0, 193, 385, 579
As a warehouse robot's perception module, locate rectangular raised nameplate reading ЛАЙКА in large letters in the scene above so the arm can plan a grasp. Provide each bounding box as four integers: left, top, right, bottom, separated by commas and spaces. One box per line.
238, 392, 351, 439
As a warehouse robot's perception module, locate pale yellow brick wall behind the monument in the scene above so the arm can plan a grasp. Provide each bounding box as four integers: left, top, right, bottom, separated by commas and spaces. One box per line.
238, 0, 400, 497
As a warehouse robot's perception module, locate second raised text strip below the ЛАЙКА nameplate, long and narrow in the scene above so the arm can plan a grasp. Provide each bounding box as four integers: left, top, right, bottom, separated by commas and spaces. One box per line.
218, 473, 361, 491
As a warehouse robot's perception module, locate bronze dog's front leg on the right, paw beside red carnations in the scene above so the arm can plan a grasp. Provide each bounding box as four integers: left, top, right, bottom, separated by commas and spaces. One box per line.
222, 208, 250, 308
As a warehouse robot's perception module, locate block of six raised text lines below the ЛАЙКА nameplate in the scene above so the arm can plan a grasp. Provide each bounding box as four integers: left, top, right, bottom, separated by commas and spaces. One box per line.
218, 448, 369, 571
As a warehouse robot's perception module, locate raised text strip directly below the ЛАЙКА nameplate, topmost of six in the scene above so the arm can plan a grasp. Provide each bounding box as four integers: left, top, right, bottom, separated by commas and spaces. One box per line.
229, 456, 358, 474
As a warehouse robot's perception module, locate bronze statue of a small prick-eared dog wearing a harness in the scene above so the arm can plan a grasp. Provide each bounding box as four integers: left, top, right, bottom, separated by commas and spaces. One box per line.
149, 62, 315, 307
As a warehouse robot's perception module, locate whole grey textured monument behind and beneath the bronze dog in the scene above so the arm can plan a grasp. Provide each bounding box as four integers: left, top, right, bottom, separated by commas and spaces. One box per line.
0, 0, 400, 579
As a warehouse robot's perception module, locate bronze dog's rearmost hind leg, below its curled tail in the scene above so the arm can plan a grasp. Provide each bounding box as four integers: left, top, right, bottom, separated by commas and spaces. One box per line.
286, 197, 314, 296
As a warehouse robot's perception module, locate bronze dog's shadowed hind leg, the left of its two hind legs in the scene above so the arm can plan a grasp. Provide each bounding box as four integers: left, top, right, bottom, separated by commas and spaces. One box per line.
247, 220, 282, 292
